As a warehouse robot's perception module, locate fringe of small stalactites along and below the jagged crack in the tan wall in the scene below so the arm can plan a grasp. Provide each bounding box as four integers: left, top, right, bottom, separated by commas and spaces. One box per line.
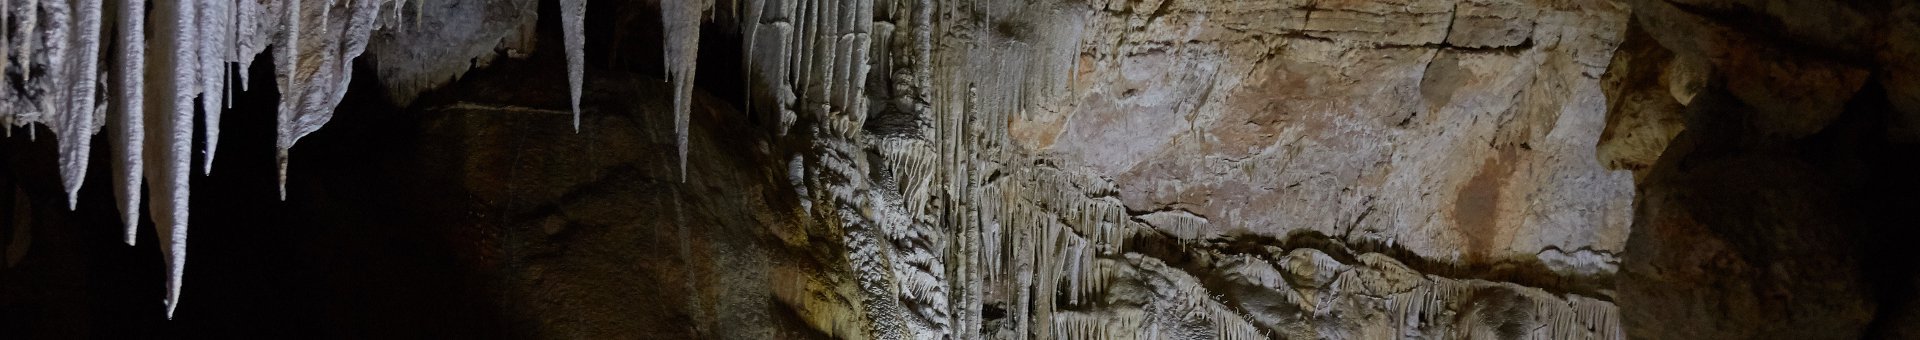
958, 160, 1620, 338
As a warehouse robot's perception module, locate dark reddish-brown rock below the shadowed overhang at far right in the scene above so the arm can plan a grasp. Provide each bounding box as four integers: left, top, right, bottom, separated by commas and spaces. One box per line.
1620, 92, 1876, 338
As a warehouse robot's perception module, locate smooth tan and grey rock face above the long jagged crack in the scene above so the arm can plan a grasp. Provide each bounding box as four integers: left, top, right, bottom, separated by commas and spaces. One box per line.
1014, 2, 1630, 263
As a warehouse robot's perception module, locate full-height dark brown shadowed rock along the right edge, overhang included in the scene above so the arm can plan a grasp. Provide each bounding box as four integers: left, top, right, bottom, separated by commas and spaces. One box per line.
1601, 2, 1920, 338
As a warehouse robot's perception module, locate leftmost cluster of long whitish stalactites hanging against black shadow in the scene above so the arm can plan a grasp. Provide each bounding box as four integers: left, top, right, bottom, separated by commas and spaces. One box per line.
0, 0, 259, 315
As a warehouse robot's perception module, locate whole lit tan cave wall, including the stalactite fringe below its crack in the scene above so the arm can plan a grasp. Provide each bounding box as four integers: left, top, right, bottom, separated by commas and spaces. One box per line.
898, 2, 1632, 338
